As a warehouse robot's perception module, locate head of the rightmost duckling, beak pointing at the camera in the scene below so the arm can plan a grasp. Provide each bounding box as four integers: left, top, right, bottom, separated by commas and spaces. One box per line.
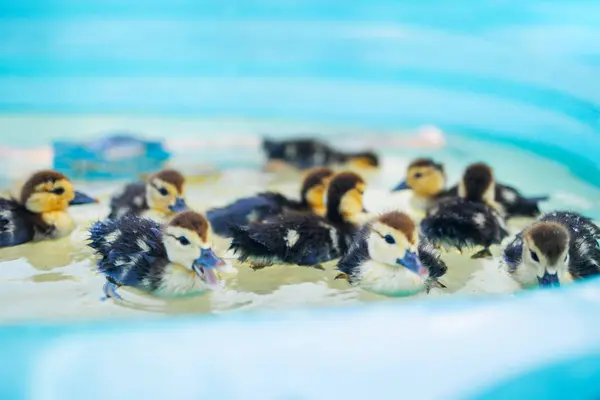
521, 222, 570, 287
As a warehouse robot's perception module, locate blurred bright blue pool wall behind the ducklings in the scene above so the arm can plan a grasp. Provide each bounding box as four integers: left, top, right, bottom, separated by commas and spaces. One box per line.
0, 0, 600, 182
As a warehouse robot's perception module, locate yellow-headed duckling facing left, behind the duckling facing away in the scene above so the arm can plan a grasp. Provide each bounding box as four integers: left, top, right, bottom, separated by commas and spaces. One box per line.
393, 158, 549, 219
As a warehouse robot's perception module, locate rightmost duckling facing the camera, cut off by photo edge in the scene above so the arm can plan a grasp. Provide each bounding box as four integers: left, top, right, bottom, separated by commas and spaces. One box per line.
504, 211, 600, 287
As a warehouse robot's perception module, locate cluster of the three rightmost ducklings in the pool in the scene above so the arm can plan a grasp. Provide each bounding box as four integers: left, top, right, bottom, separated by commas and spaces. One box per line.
394, 159, 600, 287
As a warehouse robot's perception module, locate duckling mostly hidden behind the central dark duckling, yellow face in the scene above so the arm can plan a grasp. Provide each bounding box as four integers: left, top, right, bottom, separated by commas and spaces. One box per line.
206, 167, 333, 237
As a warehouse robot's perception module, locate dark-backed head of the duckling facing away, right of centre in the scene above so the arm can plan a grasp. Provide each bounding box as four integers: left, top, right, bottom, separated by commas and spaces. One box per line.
458, 163, 496, 205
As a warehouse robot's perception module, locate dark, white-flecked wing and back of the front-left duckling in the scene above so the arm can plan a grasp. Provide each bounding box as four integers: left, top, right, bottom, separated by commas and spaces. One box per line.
88, 215, 168, 289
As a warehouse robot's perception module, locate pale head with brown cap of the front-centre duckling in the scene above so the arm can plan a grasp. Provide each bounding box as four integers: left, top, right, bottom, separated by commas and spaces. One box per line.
367, 211, 429, 277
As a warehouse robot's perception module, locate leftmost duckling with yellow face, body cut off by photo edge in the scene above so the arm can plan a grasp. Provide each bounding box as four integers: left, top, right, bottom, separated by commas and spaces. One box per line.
0, 171, 97, 247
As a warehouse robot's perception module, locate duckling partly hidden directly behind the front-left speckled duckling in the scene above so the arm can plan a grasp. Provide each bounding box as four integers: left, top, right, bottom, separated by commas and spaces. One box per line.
108, 169, 187, 219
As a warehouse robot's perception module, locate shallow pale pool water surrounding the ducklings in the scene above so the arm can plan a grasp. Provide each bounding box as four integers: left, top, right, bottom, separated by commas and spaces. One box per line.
0, 126, 600, 321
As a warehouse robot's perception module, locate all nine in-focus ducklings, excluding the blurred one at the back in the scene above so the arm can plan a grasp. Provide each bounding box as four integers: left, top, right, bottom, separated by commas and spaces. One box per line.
0, 159, 600, 298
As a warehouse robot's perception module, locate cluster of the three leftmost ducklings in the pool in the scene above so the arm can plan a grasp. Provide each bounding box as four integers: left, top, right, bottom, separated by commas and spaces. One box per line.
0, 170, 226, 298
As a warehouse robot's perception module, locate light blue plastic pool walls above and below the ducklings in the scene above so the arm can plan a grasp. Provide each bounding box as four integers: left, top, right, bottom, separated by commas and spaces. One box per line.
0, 0, 600, 399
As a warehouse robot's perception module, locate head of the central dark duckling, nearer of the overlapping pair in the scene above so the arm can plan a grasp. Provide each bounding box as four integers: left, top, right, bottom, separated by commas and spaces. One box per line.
326, 172, 366, 222
